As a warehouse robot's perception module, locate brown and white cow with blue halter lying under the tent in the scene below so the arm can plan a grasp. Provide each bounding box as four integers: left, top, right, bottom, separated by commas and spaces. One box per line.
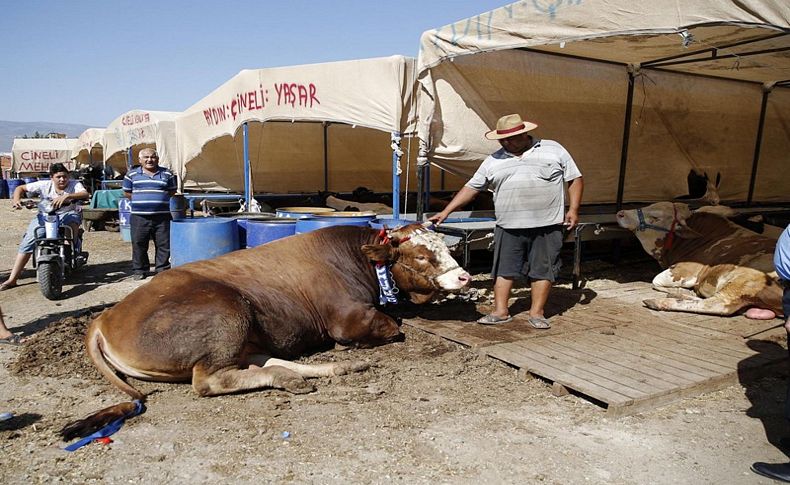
617, 202, 782, 319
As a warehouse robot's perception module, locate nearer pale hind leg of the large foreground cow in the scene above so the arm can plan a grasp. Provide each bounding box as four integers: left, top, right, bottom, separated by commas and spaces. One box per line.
192, 365, 315, 396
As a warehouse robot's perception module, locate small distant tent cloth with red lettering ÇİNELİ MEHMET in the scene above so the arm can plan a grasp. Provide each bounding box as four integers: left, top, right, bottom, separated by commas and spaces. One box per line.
11, 138, 77, 173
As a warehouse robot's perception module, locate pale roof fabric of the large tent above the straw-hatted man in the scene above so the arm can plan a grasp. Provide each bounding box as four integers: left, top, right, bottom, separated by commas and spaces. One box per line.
418, 0, 790, 73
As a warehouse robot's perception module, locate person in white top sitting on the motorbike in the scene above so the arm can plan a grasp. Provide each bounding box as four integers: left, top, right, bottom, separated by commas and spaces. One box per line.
0, 163, 90, 291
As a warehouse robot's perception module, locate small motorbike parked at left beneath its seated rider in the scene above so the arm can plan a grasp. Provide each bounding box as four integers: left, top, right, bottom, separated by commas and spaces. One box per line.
23, 199, 88, 300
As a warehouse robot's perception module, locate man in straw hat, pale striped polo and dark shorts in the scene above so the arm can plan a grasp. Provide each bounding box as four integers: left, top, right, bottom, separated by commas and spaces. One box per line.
430, 114, 584, 329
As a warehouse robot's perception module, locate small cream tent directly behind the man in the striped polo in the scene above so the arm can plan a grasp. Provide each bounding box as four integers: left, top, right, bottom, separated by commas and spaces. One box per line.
103, 110, 181, 179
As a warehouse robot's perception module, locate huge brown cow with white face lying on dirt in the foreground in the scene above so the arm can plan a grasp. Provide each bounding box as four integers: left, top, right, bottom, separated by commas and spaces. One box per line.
63, 223, 470, 439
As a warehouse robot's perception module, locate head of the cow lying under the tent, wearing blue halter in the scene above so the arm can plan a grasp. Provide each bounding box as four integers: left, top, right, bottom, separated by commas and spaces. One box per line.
617, 202, 700, 262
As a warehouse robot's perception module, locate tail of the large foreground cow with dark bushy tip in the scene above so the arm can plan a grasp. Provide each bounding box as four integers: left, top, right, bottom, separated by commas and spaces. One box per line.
60, 317, 145, 441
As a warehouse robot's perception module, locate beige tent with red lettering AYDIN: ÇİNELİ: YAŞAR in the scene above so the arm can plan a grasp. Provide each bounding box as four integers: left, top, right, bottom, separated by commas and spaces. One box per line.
176, 56, 416, 193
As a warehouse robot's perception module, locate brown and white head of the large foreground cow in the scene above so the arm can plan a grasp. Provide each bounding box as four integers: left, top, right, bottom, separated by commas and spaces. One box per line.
362, 222, 471, 303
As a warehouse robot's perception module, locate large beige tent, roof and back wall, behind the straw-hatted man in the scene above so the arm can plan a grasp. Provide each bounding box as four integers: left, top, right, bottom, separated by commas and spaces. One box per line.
418, 0, 790, 203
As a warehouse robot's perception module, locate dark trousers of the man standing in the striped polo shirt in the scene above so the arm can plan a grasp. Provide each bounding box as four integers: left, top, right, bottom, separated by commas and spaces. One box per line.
130, 214, 170, 274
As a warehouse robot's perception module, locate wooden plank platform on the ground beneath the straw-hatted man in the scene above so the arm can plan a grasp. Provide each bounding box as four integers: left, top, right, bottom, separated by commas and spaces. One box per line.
404, 283, 788, 416
